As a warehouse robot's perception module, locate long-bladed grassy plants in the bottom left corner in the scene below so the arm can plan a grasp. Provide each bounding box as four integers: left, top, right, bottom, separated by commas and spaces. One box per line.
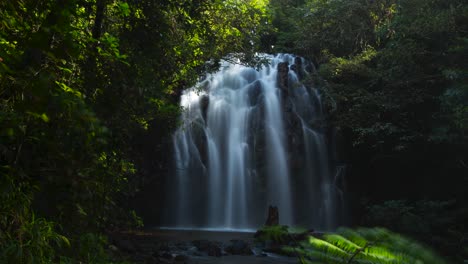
0, 170, 70, 263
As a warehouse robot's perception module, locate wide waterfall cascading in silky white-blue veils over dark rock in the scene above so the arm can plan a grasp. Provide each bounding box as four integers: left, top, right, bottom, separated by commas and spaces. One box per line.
163, 54, 342, 229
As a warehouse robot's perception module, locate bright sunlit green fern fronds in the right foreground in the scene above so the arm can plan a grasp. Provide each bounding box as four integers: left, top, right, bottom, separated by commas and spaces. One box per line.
288, 228, 445, 264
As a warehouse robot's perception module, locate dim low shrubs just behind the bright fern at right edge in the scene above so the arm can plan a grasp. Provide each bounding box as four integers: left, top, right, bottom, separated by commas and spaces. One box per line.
364, 200, 468, 261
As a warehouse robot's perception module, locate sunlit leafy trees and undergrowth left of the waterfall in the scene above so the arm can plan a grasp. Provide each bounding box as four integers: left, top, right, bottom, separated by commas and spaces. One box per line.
0, 0, 268, 263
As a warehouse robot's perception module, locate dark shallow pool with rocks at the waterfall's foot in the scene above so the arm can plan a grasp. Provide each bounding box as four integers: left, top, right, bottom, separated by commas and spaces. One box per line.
109, 229, 297, 264
